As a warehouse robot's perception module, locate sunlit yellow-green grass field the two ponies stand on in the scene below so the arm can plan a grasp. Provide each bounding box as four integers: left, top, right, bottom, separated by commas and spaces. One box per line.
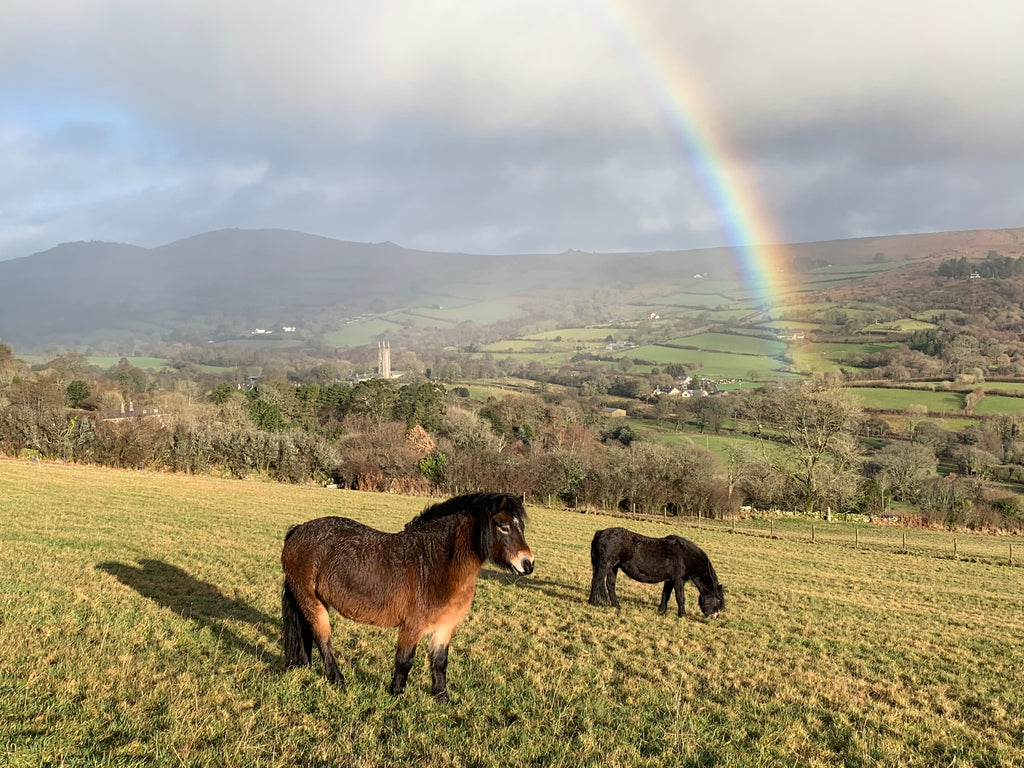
0, 460, 1024, 767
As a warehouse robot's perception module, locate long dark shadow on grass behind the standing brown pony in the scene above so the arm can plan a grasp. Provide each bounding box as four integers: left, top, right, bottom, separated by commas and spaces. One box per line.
96, 560, 279, 659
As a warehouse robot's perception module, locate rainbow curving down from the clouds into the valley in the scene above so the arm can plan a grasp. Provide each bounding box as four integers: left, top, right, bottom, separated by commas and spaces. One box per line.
595, 0, 782, 304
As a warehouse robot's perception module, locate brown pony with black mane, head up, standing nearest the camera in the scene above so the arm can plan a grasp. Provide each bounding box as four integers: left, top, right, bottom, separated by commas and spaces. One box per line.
281, 494, 534, 701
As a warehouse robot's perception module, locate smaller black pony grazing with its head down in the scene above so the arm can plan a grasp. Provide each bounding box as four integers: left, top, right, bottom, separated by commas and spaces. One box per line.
590, 528, 725, 618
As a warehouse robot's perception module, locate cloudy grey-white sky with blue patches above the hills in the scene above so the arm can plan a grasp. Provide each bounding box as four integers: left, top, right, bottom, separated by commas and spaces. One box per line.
0, 0, 1024, 259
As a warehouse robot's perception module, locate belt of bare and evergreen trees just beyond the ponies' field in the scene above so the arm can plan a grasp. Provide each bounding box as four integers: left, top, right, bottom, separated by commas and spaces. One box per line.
0, 345, 1024, 529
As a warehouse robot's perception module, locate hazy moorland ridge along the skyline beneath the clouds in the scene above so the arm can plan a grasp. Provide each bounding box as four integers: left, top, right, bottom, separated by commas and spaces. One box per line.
0, 228, 1024, 350
